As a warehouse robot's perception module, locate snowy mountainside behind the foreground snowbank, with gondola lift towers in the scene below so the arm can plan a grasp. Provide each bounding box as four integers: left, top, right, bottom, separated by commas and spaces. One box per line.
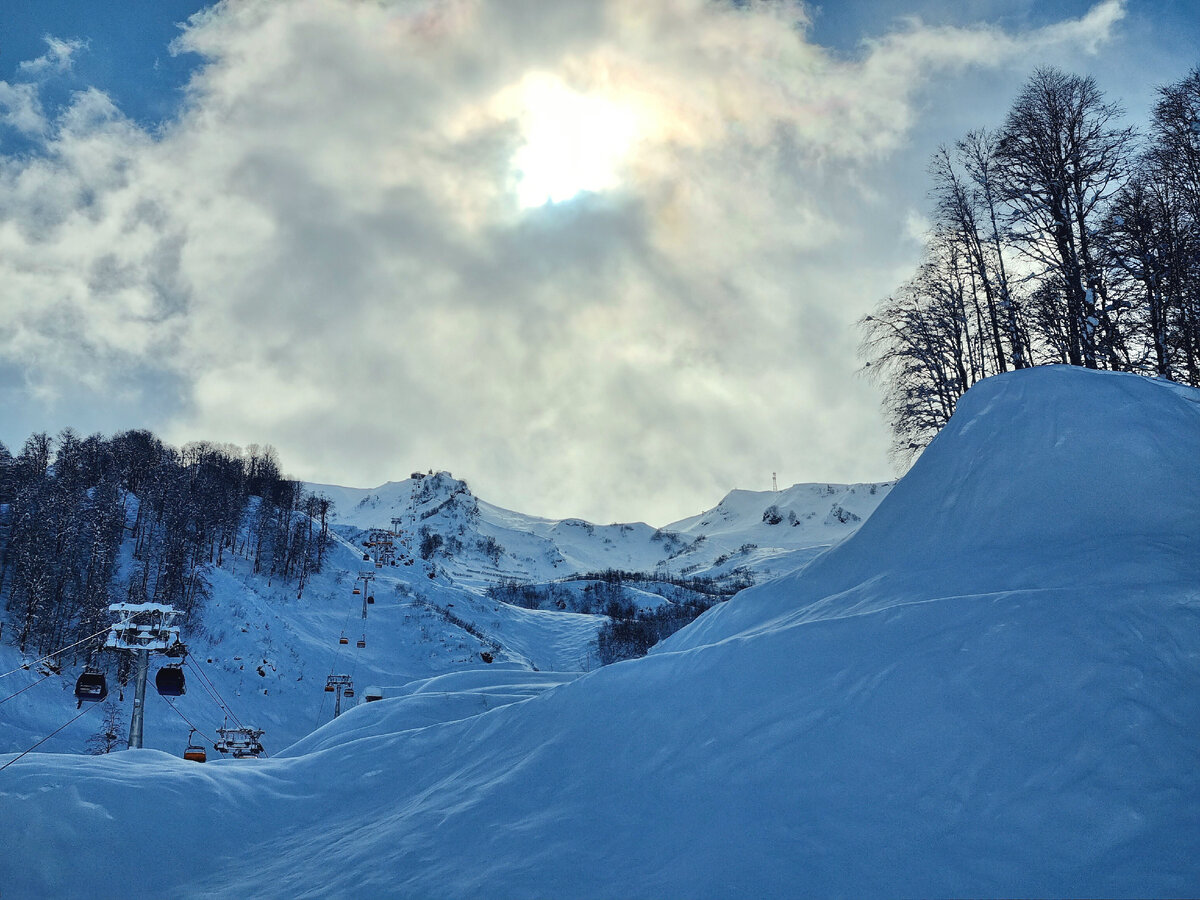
0, 473, 889, 752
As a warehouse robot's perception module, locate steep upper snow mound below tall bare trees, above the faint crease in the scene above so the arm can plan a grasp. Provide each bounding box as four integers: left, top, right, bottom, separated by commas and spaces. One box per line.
662, 366, 1200, 649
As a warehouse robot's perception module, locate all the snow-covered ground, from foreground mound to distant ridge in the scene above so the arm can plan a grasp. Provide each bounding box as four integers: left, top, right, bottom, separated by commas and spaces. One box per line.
0, 367, 1200, 898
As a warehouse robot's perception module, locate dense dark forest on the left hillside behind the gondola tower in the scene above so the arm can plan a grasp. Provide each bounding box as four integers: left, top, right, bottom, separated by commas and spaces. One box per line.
0, 428, 331, 655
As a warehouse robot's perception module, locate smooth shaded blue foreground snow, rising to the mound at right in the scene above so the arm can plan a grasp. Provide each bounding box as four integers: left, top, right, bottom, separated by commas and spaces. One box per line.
0, 367, 1200, 900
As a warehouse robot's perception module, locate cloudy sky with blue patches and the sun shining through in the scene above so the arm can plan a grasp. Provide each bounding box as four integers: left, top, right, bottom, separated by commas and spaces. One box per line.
0, 0, 1200, 526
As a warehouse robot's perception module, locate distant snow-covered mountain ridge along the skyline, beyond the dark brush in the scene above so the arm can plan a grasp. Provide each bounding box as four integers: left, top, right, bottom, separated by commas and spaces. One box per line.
308, 472, 892, 587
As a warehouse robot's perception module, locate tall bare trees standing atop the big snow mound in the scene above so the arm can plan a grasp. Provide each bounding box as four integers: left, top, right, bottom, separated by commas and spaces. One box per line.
859, 67, 1200, 461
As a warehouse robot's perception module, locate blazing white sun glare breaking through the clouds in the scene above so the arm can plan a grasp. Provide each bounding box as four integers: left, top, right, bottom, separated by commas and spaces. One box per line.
512, 76, 636, 209
